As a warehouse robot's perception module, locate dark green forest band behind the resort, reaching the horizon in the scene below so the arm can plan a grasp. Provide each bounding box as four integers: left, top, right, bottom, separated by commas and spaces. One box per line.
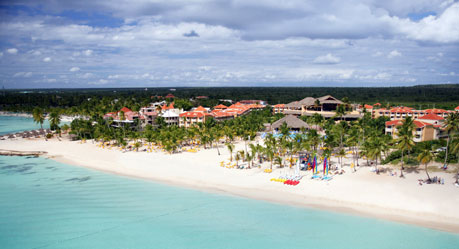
0, 84, 459, 115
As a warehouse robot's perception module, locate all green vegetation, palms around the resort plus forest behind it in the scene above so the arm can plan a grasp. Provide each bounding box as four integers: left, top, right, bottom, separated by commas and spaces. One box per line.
0, 85, 459, 177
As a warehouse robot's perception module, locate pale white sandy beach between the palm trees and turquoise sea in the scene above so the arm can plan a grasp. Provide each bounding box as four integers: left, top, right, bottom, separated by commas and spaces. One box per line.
0, 136, 459, 233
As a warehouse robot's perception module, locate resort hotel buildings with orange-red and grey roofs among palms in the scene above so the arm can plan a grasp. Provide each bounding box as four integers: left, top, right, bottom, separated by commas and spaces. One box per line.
104, 94, 459, 142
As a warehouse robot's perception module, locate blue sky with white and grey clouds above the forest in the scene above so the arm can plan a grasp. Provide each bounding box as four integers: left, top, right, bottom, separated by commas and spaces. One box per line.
0, 0, 459, 88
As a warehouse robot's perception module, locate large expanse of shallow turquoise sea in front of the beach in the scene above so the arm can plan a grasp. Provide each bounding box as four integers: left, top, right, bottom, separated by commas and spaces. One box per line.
0, 155, 459, 249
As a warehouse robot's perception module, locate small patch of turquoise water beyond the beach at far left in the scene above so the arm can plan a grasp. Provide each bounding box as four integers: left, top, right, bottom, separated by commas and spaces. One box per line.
0, 116, 49, 135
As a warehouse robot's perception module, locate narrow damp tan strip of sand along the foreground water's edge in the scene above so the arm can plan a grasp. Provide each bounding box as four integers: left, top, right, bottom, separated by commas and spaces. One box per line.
54, 155, 459, 234
